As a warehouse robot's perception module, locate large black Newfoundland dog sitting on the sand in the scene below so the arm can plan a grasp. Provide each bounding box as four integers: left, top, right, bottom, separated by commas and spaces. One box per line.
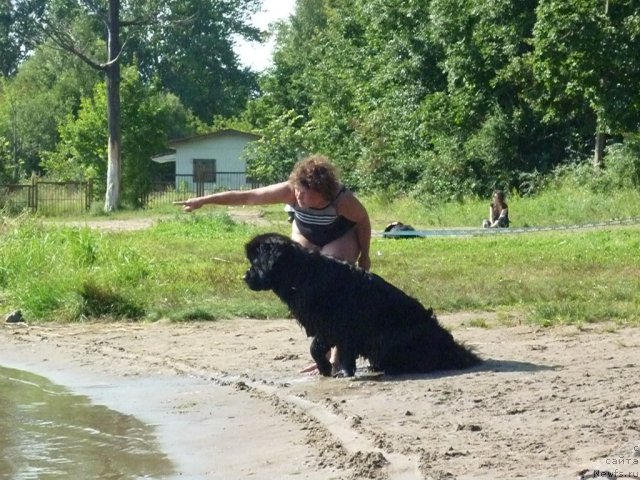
244, 233, 480, 377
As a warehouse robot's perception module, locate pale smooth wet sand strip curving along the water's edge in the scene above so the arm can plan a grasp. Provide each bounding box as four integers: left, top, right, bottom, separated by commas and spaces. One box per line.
0, 325, 327, 480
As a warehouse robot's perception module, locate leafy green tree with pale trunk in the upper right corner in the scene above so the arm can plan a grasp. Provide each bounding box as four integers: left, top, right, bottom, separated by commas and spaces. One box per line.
529, 0, 640, 166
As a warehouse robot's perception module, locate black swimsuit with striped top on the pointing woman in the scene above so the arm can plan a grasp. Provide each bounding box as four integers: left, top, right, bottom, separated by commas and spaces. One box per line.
293, 187, 356, 248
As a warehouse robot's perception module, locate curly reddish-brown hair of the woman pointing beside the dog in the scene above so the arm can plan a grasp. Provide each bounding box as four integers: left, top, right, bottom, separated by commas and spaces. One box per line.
289, 154, 340, 200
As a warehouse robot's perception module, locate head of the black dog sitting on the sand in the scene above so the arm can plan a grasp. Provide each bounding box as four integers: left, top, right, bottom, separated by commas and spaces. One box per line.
244, 233, 296, 290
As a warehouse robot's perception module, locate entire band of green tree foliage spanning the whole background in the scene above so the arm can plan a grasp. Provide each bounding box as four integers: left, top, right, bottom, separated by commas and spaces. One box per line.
0, 0, 640, 203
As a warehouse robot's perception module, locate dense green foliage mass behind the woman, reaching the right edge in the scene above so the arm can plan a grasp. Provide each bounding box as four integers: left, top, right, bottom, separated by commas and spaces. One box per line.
247, 0, 640, 198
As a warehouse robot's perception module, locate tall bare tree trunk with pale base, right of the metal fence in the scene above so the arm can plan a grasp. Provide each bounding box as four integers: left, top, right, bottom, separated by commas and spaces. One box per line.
104, 0, 122, 212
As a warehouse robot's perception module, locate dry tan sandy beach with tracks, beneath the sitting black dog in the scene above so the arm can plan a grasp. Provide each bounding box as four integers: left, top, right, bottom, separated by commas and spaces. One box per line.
0, 314, 640, 480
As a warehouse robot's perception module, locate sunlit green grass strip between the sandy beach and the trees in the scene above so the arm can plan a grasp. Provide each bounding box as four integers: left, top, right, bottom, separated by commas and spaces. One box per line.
0, 184, 640, 327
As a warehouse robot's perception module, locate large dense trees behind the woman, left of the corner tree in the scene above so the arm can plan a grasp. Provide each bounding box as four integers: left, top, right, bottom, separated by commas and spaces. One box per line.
250, 0, 534, 195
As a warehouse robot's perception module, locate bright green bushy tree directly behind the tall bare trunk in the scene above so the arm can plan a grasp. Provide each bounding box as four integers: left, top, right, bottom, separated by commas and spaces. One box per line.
42, 66, 197, 207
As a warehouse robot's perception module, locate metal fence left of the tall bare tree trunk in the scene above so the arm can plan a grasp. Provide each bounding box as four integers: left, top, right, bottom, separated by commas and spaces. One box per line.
0, 180, 93, 215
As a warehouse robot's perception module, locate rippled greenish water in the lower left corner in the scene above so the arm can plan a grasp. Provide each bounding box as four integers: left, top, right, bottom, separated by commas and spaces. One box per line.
0, 366, 175, 480
